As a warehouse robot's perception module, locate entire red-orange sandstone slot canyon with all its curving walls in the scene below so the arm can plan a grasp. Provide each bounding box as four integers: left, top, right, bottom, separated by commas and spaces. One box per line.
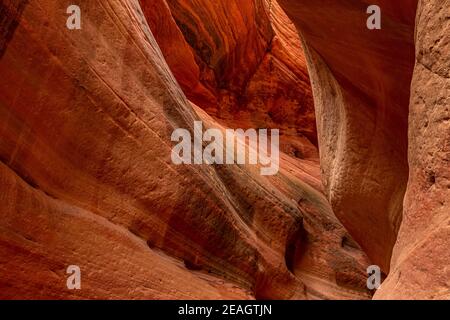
0, 0, 450, 300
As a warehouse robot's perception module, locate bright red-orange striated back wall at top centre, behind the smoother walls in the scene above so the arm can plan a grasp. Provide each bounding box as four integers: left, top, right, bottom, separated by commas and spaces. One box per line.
141, 0, 317, 144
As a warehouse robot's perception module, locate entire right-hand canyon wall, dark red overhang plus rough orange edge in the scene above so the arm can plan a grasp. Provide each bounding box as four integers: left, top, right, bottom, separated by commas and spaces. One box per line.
279, 0, 450, 299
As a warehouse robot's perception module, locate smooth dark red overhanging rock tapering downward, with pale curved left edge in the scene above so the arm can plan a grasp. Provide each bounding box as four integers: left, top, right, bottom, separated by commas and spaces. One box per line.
279, 0, 417, 273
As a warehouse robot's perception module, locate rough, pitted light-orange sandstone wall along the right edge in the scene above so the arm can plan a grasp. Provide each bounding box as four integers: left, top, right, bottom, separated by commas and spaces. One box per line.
376, 1, 450, 300
